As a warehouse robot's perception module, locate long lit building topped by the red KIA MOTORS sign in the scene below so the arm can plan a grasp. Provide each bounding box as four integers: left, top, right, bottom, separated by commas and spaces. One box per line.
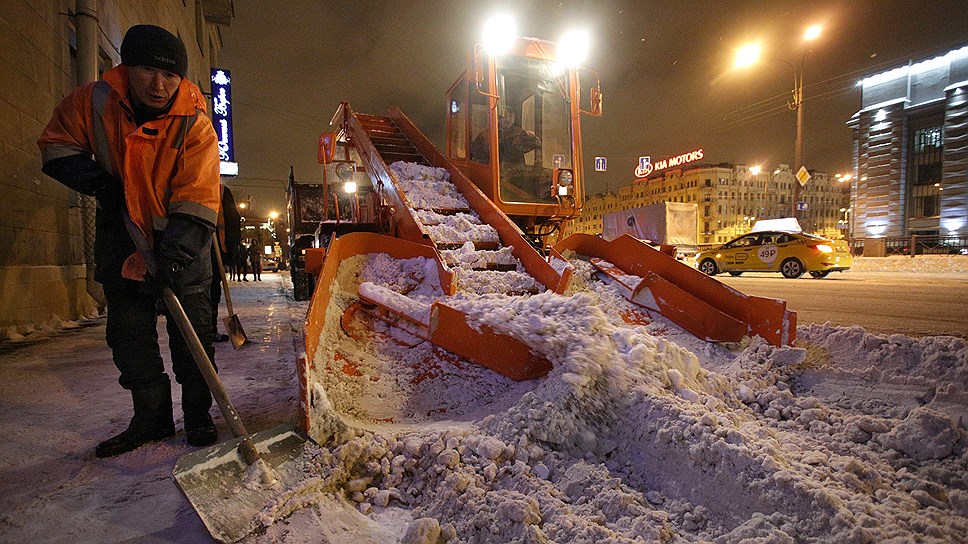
564, 163, 849, 244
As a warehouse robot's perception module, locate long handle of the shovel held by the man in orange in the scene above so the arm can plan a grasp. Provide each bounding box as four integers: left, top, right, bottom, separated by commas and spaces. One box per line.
161, 287, 259, 465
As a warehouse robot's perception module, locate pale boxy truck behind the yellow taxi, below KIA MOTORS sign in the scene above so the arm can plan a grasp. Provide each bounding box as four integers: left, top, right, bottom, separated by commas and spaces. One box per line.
602, 202, 699, 260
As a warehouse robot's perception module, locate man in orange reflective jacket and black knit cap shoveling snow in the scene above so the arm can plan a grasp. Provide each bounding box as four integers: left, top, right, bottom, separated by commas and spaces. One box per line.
38, 25, 220, 457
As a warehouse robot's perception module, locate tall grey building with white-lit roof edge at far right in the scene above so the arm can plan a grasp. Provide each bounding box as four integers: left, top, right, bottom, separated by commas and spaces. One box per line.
847, 46, 968, 237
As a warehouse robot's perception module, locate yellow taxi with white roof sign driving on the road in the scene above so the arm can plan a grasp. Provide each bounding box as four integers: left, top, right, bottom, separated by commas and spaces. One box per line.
696, 231, 853, 278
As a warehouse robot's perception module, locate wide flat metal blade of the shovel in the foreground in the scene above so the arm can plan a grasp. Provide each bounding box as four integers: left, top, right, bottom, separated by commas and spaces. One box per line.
172, 422, 311, 542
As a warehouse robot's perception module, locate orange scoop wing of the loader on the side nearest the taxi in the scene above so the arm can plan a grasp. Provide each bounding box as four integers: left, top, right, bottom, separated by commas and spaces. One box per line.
554, 234, 797, 346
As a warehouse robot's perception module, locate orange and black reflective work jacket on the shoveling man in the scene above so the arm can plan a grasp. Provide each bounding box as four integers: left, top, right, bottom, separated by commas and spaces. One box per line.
38, 65, 221, 292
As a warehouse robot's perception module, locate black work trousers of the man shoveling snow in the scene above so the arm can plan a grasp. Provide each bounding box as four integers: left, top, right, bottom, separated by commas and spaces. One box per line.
104, 280, 215, 390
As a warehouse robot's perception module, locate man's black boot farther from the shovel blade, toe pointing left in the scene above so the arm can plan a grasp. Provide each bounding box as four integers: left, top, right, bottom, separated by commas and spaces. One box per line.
94, 382, 175, 458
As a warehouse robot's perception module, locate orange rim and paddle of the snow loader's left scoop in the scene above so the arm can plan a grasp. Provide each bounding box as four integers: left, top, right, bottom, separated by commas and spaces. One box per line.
298, 232, 551, 429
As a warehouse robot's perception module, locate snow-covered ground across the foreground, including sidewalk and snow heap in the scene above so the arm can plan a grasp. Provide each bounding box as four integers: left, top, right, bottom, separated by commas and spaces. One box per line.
0, 253, 968, 544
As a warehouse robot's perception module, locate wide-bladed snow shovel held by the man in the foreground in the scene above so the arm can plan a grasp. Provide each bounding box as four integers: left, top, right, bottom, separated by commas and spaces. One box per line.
162, 287, 309, 542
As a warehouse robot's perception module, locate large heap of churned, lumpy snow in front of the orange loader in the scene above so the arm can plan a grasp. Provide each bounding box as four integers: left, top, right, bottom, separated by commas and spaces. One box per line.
270, 248, 968, 544
